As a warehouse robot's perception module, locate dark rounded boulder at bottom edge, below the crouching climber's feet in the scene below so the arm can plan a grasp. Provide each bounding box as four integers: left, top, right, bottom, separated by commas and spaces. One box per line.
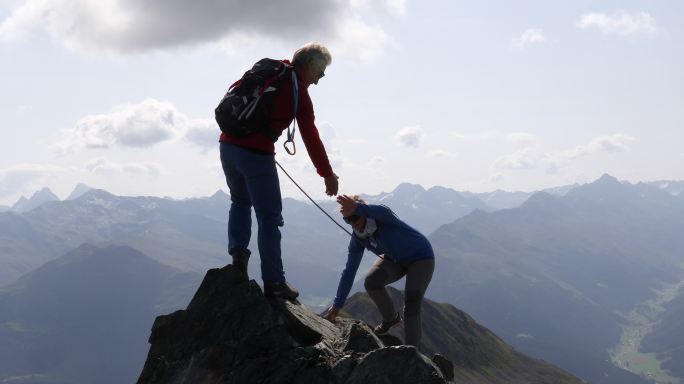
345, 345, 445, 384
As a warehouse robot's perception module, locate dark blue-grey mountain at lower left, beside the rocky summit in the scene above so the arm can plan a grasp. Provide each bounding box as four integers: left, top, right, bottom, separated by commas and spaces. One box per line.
0, 244, 201, 384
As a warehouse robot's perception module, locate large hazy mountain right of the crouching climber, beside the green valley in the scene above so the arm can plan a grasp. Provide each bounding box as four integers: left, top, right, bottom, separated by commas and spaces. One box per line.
429, 175, 684, 383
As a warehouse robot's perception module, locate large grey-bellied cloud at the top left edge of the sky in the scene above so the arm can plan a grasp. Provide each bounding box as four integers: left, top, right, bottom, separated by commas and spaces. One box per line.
0, 0, 336, 53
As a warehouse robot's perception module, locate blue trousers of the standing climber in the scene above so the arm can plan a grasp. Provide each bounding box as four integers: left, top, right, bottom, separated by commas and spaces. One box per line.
220, 143, 285, 282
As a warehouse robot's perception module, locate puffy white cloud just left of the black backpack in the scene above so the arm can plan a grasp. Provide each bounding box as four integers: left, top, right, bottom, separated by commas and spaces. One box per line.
55, 99, 219, 153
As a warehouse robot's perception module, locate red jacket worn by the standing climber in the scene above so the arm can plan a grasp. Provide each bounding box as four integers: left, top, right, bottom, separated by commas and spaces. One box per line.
219, 60, 333, 177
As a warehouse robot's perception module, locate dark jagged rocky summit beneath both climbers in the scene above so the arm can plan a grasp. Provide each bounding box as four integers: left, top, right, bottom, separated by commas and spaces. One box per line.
138, 265, 453, 384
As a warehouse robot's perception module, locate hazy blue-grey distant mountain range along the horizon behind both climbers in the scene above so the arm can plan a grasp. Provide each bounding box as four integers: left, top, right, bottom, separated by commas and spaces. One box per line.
0, 175, 684, 384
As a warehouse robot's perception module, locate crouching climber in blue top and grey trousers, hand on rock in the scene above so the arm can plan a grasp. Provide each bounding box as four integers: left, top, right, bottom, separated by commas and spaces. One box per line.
324, 195, 435, 348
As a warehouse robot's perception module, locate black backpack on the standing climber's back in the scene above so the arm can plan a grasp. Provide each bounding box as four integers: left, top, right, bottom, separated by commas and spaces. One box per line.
214, 58, 298, 142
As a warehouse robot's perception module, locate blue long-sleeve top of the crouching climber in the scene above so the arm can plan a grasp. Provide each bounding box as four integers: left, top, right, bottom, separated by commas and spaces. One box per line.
333, 204, 435, 308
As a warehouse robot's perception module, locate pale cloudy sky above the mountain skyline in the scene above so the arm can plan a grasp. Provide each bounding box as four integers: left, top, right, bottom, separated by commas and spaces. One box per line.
0, 0, 684, 205
